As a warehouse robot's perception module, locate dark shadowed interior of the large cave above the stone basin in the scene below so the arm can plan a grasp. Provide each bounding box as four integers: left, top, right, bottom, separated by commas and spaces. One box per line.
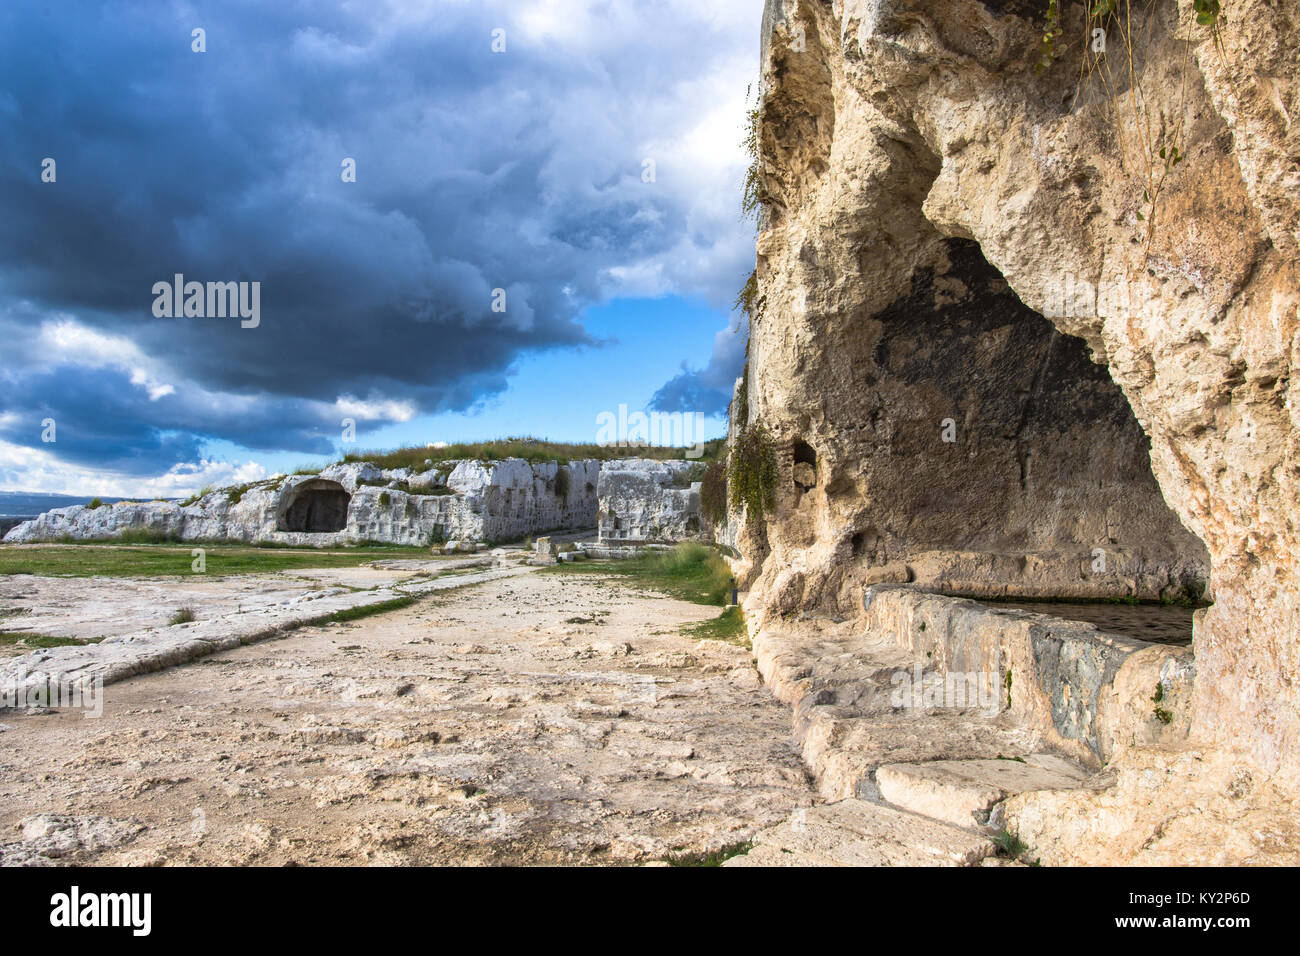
842, 238, 1209, 636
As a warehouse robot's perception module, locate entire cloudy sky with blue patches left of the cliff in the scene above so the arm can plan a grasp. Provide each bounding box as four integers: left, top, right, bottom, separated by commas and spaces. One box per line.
0, 0, 762, 497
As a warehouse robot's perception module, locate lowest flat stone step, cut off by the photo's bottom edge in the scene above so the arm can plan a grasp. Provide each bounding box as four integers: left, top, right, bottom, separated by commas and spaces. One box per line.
723, 799, 995, 866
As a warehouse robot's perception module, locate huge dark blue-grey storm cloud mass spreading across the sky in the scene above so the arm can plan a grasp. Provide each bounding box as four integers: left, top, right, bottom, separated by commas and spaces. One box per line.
0, 0, 758, 473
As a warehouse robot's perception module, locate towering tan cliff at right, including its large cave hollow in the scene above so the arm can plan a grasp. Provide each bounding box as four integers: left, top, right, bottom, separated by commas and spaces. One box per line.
737, 0, 1300, 863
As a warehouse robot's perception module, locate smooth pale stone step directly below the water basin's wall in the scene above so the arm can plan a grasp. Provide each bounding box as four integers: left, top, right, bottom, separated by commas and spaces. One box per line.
875, 753, 1089, 827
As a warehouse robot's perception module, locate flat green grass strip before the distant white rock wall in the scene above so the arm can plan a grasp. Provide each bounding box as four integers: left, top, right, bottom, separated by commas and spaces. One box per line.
0, 542, 433, 578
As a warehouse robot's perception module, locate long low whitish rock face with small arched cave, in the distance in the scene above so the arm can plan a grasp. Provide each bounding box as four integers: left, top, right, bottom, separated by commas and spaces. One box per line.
4, 458, 601, 546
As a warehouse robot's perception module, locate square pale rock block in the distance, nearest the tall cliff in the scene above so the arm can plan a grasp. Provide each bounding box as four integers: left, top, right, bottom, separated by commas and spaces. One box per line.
597, 458, 703, 544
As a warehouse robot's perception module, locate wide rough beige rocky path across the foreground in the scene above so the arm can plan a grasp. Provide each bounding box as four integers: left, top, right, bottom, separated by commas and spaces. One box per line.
0, 575, 813, 865
